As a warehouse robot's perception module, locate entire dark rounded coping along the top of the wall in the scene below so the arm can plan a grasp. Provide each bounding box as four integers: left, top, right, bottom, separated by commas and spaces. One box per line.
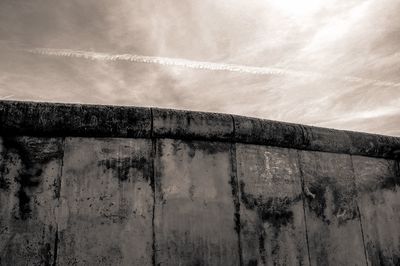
0, 101, 400, 159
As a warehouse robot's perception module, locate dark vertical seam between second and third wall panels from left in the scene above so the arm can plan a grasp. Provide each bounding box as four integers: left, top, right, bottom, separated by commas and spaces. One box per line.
150, 108, 156, 266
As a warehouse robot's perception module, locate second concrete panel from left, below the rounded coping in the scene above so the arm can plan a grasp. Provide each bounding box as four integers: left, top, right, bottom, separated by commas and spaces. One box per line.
57, 138, 153, 265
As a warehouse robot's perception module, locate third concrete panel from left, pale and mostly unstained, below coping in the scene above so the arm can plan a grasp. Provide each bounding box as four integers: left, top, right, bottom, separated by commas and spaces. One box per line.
154, 139, 239, 265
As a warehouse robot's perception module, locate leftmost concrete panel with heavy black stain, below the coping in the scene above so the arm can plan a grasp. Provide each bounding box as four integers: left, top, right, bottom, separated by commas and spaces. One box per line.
0, 137, 63, 265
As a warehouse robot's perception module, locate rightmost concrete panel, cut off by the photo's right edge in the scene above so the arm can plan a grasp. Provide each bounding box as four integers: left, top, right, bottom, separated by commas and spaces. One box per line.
353, 156, 400, 265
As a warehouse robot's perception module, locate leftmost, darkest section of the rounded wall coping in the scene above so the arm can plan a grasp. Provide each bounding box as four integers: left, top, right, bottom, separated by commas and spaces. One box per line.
0, 101, 151, 138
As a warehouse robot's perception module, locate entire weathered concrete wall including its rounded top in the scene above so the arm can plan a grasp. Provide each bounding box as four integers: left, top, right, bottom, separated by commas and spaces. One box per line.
0, 101, 400, 266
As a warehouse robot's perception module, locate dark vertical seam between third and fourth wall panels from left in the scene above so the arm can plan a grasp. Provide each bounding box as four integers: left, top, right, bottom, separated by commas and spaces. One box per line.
230, 115, 243, 266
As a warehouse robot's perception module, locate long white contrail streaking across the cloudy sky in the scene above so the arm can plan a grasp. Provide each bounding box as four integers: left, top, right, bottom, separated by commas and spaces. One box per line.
20, 48, 400, 87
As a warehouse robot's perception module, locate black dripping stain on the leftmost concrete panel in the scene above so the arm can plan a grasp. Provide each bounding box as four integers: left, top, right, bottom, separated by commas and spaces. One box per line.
0, 137, 63, 220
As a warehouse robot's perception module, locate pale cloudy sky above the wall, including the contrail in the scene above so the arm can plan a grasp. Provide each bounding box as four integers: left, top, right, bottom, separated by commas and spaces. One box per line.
0, 0, 400, 136
